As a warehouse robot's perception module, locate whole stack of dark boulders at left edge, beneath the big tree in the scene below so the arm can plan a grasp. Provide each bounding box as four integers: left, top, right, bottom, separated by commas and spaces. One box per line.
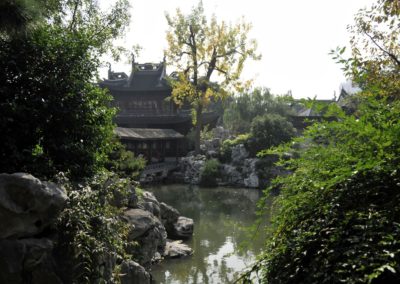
0, 173, 67, 284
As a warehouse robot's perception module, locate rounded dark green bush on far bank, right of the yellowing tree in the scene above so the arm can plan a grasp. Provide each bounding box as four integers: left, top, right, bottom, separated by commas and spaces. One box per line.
248, 114, 296, 155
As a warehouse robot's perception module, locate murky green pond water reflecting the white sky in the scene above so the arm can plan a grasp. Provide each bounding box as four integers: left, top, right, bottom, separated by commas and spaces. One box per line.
146, 185, 263, 284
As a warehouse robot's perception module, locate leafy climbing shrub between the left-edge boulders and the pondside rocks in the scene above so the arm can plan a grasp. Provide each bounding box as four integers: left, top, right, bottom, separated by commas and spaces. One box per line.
56, 173, 134, 283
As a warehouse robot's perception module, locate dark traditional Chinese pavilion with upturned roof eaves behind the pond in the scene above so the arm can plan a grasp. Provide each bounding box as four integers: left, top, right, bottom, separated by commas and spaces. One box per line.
99, 56, 218, 163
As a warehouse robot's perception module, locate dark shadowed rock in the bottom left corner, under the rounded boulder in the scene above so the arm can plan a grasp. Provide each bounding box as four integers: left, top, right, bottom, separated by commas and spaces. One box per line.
0, 238, 63, 284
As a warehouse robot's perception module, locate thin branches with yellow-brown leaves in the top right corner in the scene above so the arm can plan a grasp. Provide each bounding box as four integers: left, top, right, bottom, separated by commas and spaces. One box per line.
332, 0, 400, 97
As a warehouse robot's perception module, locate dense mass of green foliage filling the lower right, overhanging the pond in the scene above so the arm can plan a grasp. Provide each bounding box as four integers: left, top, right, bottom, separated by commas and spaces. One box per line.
241, 95, 400, 283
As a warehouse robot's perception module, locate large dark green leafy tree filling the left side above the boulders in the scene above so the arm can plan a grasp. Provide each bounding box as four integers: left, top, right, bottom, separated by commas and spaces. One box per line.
0, 0, 129, 179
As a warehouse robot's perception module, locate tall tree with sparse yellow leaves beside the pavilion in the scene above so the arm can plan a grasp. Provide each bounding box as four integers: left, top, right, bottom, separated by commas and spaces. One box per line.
166, 2, 260, 153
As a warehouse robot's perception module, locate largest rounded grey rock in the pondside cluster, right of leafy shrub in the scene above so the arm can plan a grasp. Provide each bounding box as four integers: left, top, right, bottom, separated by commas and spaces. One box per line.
123, 209, 167, 265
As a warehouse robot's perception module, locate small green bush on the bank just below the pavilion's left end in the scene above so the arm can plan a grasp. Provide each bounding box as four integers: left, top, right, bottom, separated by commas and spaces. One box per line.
106, 142, 146, 178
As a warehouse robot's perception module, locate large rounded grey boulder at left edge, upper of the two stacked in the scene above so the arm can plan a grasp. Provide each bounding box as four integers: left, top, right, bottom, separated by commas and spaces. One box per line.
0, 173, 67, 239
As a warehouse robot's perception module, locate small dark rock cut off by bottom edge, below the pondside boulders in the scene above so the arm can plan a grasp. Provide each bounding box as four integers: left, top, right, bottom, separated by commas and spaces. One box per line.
121, 260, 151, 284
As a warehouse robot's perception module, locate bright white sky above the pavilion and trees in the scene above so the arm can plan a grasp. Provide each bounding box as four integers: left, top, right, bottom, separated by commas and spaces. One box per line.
100, 0, 373, 99
